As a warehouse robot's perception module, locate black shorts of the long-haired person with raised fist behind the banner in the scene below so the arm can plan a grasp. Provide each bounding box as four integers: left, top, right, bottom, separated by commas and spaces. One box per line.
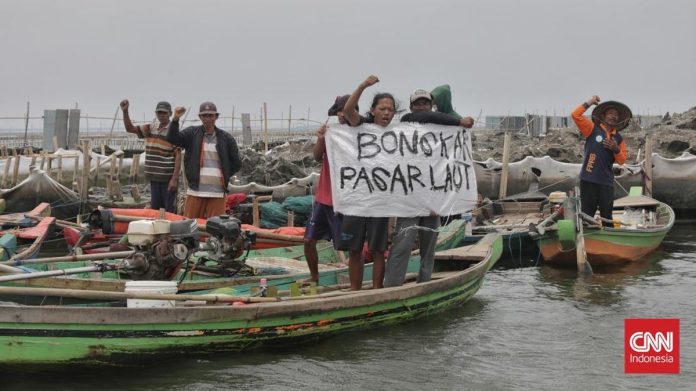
338, 216, 389, 252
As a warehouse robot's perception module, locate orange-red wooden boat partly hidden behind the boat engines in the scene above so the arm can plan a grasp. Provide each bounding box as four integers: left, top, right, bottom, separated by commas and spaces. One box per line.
63, 208, 305, 254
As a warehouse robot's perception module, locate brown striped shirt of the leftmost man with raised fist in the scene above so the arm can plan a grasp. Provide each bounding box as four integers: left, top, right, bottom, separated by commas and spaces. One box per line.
138, 121, 177, 182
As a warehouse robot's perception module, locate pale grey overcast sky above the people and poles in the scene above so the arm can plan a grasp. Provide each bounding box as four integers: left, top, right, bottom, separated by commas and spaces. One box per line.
0, 0, 696, 125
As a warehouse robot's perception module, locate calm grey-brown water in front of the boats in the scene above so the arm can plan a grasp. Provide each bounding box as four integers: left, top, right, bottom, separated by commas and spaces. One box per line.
0, 225, 696, 391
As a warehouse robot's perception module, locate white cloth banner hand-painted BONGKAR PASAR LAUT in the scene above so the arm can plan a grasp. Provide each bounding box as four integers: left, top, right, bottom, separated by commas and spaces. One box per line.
326, 123, 477, 217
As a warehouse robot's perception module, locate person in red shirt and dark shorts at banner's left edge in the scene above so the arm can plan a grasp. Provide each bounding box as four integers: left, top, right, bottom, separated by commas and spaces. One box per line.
304, 95, 357, 282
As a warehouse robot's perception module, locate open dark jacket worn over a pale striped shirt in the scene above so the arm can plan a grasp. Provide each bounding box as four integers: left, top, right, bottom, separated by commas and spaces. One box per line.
167, 120, 242, 192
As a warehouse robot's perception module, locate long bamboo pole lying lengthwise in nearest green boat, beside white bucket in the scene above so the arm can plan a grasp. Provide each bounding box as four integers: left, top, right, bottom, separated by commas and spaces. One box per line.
0, 286, 280, 303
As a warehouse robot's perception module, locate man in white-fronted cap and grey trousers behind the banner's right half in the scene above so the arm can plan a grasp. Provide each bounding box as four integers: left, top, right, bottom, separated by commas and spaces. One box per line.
384, 89, 474, 288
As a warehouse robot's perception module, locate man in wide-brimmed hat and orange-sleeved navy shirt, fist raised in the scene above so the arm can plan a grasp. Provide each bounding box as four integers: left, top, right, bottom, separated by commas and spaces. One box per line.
572, 95, 633, 225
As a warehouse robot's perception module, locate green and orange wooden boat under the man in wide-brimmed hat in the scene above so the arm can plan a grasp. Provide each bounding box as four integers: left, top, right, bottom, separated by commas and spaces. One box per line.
537, 194, 674, 267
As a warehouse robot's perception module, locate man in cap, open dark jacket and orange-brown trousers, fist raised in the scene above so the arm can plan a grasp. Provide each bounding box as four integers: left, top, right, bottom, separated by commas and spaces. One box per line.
167, 102, 241, 219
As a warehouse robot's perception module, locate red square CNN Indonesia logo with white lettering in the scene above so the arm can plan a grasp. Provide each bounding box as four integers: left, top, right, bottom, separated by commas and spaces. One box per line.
624, 319, 679, 374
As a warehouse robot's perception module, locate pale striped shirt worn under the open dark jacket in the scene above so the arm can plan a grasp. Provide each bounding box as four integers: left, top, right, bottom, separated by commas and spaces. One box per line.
186, 133, 226, 198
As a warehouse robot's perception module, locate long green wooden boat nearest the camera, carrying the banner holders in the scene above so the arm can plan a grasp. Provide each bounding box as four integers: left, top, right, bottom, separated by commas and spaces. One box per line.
0, 234, 502, 364
